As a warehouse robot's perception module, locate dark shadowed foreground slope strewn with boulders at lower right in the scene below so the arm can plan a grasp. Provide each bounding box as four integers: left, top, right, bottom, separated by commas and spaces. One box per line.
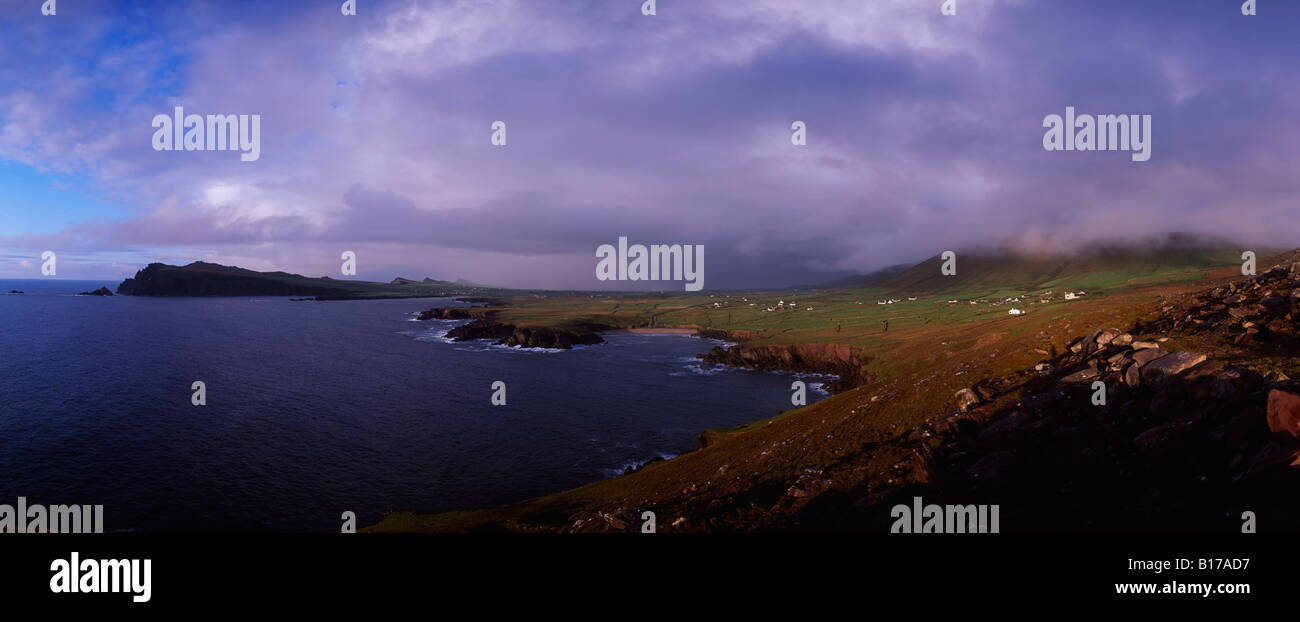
784, 264, 1300, 532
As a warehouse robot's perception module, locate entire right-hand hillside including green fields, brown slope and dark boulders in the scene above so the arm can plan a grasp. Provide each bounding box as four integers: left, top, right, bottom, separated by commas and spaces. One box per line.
368, 245, 1300, 532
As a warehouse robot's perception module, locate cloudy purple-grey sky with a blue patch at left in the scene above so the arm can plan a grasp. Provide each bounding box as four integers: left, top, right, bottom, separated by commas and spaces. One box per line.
0, 0, 1300, 289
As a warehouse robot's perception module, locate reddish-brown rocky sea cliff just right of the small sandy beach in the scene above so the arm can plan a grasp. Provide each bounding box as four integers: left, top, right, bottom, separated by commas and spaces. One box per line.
699, 344, 870, 392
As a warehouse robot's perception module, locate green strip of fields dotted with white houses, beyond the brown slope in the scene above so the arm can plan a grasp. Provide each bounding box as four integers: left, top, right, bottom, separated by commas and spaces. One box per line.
480, 250, 1240, 349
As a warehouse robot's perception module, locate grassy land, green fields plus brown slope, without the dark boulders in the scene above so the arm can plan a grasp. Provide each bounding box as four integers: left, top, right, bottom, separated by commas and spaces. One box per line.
369, 245, 1268, 531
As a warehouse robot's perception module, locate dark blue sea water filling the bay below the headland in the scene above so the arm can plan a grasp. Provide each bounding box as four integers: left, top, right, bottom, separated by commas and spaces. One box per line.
0, 280, 822, 532
